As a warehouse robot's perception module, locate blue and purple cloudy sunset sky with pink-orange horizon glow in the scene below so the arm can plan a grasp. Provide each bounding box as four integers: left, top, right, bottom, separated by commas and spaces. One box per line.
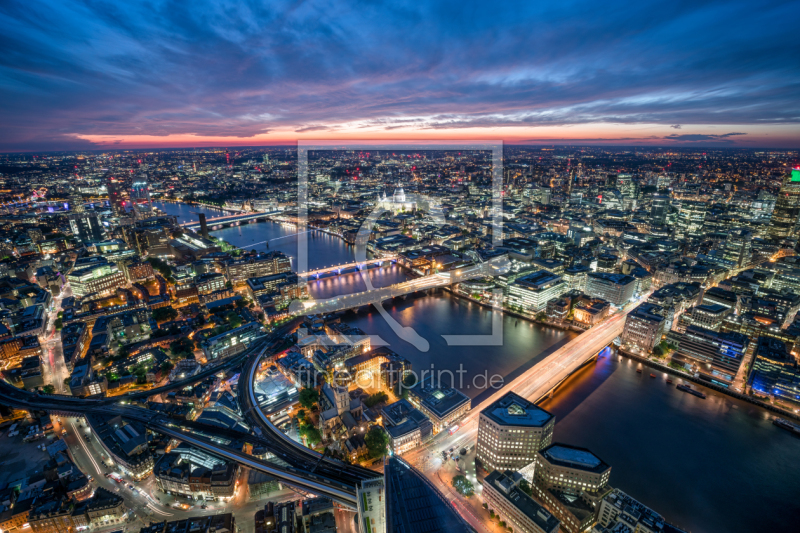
0, 0, 800, 152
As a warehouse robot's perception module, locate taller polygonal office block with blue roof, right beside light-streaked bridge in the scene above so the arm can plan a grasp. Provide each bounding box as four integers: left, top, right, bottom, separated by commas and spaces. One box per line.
475, 392, 556, 471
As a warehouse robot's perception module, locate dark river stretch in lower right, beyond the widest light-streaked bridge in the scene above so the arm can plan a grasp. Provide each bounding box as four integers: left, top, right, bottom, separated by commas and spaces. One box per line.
542, 354, 800, 533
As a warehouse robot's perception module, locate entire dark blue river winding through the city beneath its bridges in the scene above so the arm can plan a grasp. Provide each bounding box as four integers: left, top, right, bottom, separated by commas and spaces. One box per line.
156, 204, 800, 533
